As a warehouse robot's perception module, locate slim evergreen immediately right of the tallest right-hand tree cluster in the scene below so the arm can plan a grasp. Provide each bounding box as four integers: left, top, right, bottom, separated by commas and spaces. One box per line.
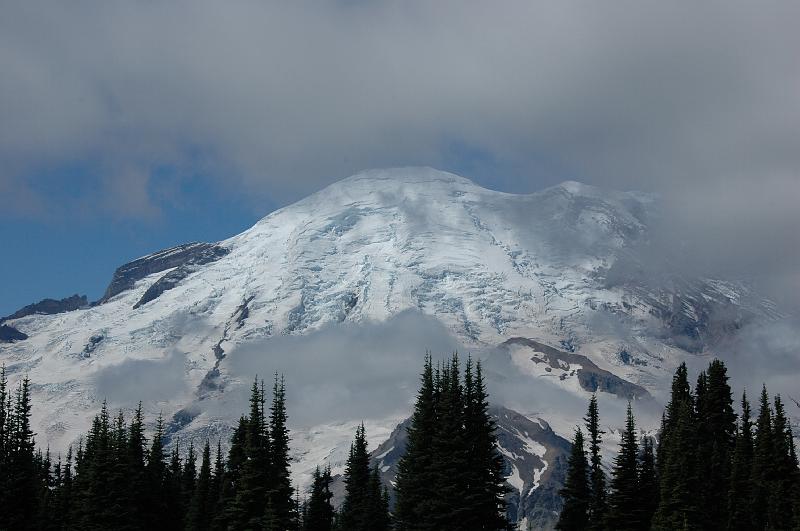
727, 392, 756, 531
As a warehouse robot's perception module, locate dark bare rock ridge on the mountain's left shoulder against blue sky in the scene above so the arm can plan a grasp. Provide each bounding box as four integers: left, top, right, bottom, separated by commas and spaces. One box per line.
97, 242, 228, 306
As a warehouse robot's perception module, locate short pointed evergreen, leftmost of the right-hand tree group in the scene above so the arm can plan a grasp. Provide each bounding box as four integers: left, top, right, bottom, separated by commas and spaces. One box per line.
556, 428, 591, 531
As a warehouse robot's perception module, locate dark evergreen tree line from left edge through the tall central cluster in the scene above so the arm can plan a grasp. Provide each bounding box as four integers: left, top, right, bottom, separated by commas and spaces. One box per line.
0, 355, 508, 531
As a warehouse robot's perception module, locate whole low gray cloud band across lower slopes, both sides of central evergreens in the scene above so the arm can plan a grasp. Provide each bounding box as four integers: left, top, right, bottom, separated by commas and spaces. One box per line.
220, 311, 661, 428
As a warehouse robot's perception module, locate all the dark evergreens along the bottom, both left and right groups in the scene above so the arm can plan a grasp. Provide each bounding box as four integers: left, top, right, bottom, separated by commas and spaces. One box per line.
7, 356, 800, 531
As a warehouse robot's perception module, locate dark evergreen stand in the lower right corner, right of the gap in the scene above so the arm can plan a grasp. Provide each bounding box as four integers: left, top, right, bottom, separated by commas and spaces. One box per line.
557, 360, 800, 531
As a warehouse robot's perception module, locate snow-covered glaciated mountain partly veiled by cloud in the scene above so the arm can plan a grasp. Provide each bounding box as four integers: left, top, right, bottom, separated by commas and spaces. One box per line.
0, 168, 772, 528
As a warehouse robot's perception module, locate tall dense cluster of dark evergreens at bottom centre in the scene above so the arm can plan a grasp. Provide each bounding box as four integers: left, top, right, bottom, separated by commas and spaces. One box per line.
395, 355, 508, 530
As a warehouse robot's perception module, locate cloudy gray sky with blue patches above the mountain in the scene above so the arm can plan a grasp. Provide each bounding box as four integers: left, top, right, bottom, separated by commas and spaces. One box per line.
0, 0, 800, 315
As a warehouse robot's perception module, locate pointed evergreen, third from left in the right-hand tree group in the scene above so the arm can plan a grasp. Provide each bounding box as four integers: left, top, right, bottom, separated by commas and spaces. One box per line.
606, 402, 646, 531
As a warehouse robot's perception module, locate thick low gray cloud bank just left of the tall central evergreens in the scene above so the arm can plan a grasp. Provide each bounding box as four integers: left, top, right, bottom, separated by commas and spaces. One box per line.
225, 312, 463, 426
